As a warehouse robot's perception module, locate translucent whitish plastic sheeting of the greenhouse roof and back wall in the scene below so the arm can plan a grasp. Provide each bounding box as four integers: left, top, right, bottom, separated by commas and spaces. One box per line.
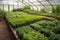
0, 0, 60, 10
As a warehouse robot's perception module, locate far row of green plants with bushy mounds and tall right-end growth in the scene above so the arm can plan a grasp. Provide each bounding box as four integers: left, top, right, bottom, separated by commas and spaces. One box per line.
13, 6, 60, 17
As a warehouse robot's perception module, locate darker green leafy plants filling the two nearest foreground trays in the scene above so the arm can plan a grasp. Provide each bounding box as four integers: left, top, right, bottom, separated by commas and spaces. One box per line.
16, 18, 60, 40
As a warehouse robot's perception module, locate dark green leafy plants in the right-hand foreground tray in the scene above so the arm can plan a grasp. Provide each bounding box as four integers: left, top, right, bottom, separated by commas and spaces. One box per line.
30, 19, 60, 40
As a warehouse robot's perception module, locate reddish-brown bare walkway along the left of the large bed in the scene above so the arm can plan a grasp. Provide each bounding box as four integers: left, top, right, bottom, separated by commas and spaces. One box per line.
0, 21, 14, 40
